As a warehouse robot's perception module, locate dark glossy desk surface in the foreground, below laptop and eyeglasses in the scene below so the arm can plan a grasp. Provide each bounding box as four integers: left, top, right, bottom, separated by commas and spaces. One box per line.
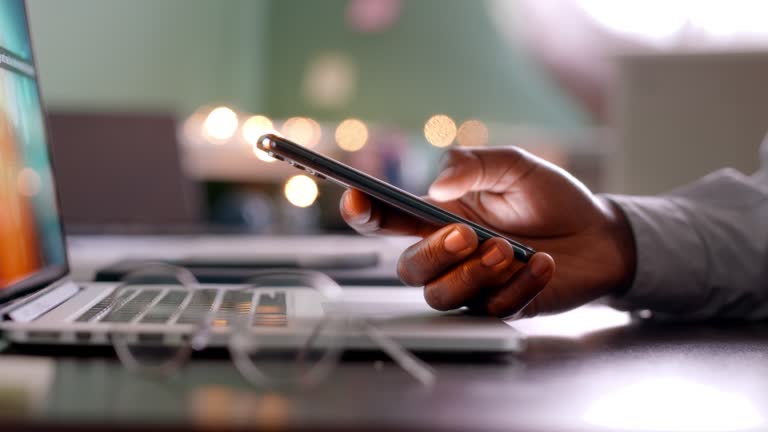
9, 306, 768, 431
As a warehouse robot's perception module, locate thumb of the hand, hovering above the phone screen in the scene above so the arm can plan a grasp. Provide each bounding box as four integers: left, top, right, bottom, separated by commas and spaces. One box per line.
429, 147, 538, 202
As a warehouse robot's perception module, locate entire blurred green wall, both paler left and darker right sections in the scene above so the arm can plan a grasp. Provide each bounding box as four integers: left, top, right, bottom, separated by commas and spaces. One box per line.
24, 0, 587, 130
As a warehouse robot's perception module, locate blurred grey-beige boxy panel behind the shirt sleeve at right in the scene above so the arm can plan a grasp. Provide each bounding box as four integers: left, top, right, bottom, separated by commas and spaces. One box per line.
607, 52, 768, 194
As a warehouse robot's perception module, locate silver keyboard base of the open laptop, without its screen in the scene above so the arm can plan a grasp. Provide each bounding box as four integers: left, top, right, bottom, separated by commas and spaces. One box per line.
0, 279, 524, 353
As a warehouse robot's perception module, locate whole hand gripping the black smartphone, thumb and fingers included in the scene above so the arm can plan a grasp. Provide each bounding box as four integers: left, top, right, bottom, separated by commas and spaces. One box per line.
341, 148, 635, 317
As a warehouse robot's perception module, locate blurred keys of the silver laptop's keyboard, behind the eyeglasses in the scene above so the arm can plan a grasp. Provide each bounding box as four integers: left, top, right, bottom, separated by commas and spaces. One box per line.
75, 288, 287, 326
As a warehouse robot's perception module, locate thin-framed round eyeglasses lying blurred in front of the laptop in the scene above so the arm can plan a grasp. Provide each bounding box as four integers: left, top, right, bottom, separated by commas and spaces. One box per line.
105, 263, 436, 388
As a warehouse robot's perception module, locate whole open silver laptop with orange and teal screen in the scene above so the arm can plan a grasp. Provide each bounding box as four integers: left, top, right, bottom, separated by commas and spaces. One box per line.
0, 0, 523, 352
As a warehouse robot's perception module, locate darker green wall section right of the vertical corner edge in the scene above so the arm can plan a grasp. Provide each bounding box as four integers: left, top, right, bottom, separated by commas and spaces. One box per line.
266, 0, 587, 130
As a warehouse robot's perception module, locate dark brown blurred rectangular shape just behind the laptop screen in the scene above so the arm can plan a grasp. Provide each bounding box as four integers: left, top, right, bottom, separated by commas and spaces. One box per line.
48, 112, 202, 232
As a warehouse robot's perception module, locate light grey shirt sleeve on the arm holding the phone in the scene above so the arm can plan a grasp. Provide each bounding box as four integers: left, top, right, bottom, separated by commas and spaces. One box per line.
607, 138, 768, 319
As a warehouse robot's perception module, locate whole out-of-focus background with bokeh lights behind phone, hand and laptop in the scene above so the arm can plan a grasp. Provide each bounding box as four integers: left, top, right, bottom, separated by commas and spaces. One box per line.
22, 0, 768, 234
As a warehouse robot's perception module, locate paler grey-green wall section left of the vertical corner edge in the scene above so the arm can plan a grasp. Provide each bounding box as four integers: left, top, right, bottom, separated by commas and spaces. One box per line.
28, 0, 267, 112
